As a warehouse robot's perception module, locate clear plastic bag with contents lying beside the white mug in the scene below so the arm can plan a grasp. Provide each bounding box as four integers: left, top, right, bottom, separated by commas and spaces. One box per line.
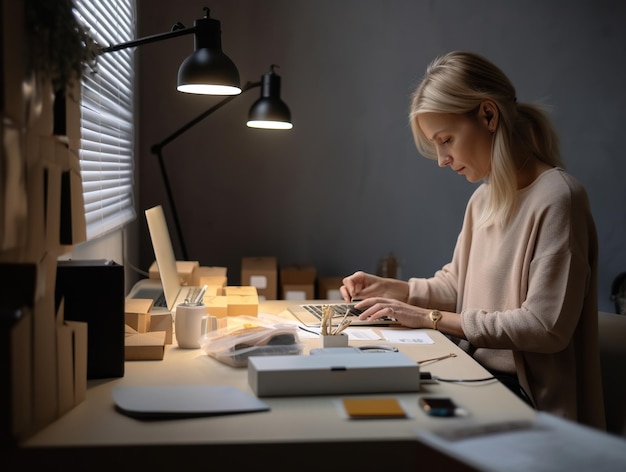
201, 316, 304, 367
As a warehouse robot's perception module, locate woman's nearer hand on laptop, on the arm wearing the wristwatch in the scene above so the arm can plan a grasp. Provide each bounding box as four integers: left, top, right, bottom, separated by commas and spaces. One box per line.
354, 297, 433, 328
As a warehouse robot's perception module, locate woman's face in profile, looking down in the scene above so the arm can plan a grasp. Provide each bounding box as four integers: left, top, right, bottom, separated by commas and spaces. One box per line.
417, 112, 493, 183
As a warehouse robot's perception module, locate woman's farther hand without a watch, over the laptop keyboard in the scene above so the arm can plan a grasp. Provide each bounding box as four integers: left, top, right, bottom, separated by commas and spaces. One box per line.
339, 271, 409, 302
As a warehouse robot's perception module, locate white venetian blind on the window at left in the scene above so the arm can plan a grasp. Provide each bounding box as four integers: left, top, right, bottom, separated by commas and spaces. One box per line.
74, 0, 136, 239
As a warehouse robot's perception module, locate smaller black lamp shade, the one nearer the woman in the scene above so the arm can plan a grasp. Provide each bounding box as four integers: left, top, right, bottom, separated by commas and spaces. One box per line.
247, 70, 293, 129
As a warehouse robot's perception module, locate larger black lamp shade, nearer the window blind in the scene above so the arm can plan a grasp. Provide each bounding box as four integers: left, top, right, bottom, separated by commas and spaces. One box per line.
178, 13, 241, 95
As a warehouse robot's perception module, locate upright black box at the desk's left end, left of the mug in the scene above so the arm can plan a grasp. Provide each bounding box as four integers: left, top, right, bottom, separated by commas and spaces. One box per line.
55, 259, 125, 379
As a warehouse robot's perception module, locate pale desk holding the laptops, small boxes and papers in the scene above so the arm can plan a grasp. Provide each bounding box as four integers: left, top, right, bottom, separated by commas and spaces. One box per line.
0, 301, 535, 472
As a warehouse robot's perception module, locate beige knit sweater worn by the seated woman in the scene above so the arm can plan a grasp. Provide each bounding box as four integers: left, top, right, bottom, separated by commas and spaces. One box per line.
409, 169, 597, 353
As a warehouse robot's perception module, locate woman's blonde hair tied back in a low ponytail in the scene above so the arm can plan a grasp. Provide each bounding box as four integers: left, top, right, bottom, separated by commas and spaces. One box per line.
409, 51, 564, 225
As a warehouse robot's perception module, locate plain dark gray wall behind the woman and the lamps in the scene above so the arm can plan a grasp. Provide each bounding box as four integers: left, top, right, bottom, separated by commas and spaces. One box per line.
134, 0, 626, 311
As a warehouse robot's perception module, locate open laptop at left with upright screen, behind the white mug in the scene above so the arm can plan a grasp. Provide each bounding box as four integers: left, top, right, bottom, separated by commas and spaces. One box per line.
127, 205, 203, 313
